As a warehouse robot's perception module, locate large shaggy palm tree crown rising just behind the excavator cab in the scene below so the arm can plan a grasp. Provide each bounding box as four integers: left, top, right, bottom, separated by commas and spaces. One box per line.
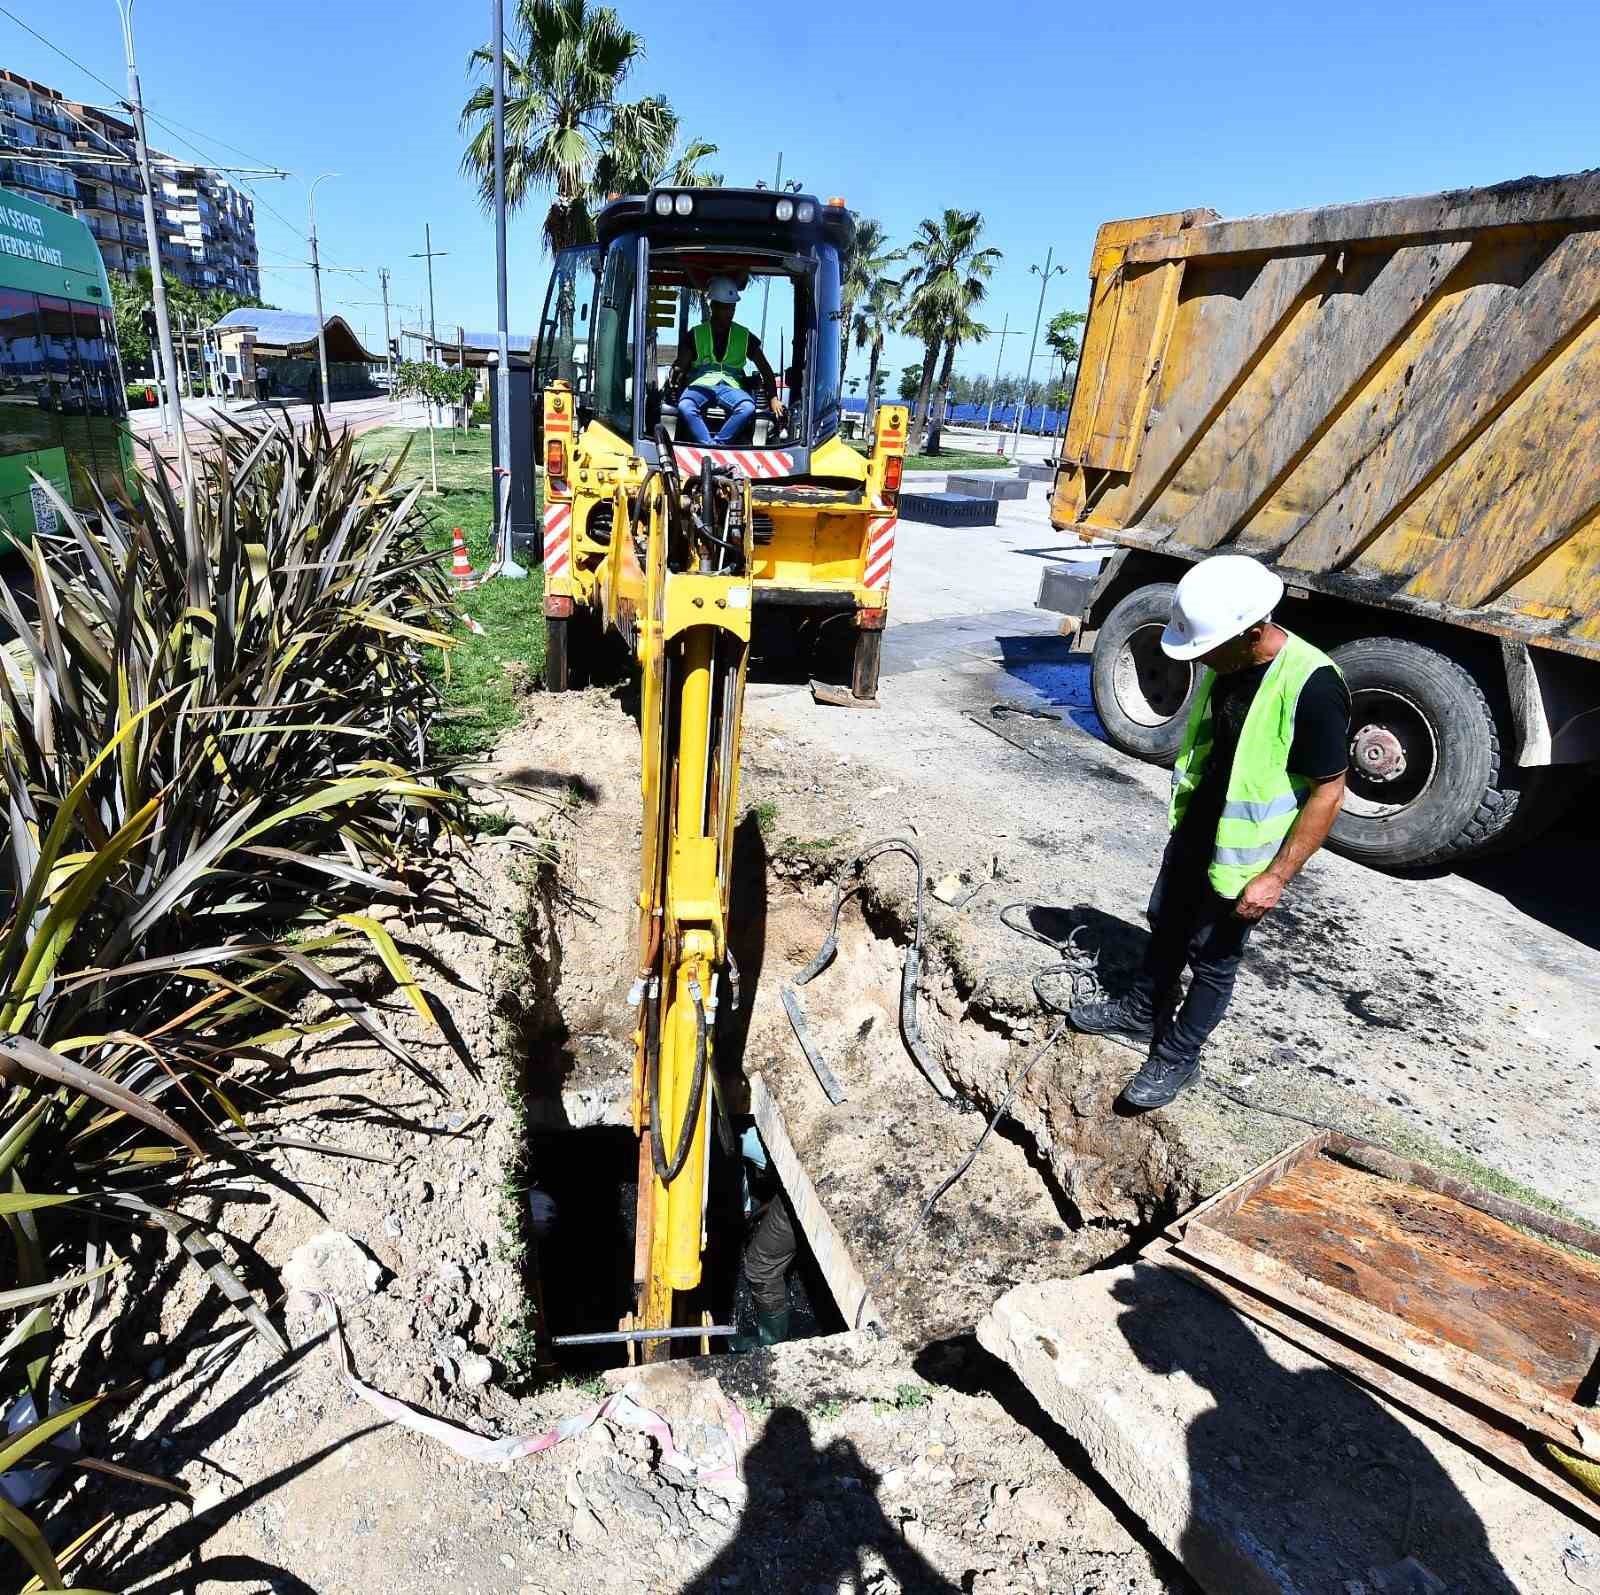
461, 0, 697, 250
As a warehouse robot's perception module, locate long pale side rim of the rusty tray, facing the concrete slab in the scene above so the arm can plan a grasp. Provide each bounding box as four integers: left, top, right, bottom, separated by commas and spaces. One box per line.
1178, 1224, 1600, 1461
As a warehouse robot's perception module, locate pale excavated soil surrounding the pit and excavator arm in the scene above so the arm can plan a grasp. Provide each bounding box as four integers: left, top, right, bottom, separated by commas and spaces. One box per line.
50, 691, 1189, 1595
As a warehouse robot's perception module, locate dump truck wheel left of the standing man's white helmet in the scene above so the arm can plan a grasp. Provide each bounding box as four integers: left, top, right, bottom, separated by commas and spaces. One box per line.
1090, 582, 1197, 765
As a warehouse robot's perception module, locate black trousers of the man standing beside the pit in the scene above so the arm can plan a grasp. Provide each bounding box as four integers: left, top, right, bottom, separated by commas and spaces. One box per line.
1134, 830, 1254, 1067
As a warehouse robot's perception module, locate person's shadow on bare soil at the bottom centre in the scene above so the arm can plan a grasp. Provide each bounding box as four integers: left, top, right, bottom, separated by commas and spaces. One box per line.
680, 1406, 960, 1595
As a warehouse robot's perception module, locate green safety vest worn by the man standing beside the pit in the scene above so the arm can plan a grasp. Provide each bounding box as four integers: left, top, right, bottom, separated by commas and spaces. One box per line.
1170, 632, 1342, 897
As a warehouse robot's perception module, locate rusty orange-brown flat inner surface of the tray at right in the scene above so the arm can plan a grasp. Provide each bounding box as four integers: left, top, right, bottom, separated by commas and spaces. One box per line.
1206, 1158, 1600, 1400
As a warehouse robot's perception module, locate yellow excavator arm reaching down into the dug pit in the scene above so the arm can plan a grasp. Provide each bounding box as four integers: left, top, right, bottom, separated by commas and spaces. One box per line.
616, 446, 752, 1361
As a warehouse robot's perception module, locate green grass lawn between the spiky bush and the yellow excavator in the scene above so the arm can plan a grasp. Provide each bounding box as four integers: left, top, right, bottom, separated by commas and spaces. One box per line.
358, 427, 544, 758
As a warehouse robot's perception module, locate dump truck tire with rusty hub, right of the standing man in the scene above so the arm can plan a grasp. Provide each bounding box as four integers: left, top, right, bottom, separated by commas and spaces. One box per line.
1328, 637, 1526, 869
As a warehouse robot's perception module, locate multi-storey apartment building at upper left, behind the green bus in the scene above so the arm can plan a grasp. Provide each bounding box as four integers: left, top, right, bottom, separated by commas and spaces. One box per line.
0, 69, 261, 298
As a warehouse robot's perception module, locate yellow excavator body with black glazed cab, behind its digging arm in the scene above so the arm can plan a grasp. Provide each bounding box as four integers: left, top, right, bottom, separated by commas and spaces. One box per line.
534, 189, 906, 699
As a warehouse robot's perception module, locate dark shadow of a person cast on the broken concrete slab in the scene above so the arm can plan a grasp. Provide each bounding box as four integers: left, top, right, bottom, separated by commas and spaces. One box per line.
1114, 1267, 1518, 1595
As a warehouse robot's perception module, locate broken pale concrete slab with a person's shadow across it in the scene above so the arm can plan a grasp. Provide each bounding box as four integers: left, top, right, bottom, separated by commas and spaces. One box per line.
978, 1262, 1600, 1595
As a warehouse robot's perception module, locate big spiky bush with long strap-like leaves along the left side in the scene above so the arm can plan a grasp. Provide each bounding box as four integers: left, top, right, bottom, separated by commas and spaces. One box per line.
0, 407, 456, 1567
